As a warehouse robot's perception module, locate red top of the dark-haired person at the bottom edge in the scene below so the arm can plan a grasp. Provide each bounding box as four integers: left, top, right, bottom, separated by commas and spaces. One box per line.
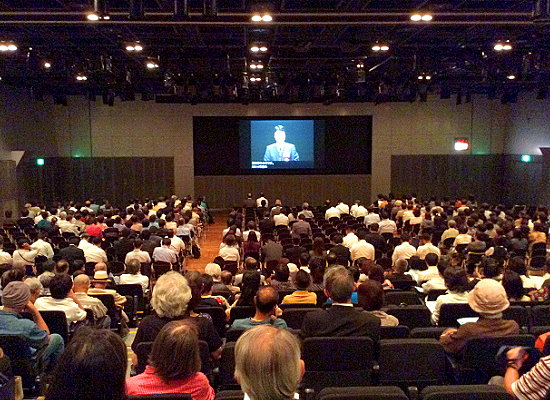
126, 365, 215, 400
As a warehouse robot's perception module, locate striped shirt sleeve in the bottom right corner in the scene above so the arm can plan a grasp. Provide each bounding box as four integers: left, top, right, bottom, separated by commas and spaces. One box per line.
512, 356, 550, 400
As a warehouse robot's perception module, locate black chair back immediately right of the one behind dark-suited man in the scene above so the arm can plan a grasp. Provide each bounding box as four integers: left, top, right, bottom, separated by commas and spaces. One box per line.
378, 339, 447, 388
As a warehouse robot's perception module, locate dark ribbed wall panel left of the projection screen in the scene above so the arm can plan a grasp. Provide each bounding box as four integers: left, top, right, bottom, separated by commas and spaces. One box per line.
17, 157, 174, 204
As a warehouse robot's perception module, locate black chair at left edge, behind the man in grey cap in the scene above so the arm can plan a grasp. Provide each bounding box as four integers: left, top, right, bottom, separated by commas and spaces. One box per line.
0, 335, 46, 390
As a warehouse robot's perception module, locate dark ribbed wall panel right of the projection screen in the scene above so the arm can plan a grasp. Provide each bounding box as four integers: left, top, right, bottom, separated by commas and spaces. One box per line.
391, 154, 545, 204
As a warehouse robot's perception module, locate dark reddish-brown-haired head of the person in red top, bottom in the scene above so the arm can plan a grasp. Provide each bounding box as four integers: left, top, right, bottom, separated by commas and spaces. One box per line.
149, 320, 201, 383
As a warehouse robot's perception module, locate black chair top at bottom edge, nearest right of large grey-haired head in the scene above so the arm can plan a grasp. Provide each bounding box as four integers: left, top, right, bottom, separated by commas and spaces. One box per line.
317, 386, 408, 400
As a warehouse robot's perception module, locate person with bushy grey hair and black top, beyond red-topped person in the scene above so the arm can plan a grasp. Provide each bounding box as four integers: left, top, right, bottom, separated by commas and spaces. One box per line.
132, 271, 222, 365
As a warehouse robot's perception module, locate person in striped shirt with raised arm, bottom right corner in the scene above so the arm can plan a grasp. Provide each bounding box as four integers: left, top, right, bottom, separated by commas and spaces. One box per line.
504, 347, 550, 400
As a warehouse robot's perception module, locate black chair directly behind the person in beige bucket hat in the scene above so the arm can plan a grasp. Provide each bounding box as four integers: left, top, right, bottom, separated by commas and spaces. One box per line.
455, 335, 535, 385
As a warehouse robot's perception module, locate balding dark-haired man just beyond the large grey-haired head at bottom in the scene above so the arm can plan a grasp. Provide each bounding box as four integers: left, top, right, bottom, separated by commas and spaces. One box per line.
231, 286, 288, 329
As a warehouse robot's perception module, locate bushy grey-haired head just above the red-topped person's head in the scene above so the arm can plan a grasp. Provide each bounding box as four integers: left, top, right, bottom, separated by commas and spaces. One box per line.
151, 271, 191, 318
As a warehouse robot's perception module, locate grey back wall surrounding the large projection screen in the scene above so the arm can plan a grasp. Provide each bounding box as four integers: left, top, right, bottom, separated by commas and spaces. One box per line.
0, 88, 549, 206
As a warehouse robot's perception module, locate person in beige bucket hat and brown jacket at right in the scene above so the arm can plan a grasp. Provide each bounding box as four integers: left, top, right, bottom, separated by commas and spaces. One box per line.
439, 279, 519, 354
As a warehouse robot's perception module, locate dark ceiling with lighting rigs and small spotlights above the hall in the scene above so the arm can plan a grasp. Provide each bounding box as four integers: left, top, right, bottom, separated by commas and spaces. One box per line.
0, 0, 550, 102
